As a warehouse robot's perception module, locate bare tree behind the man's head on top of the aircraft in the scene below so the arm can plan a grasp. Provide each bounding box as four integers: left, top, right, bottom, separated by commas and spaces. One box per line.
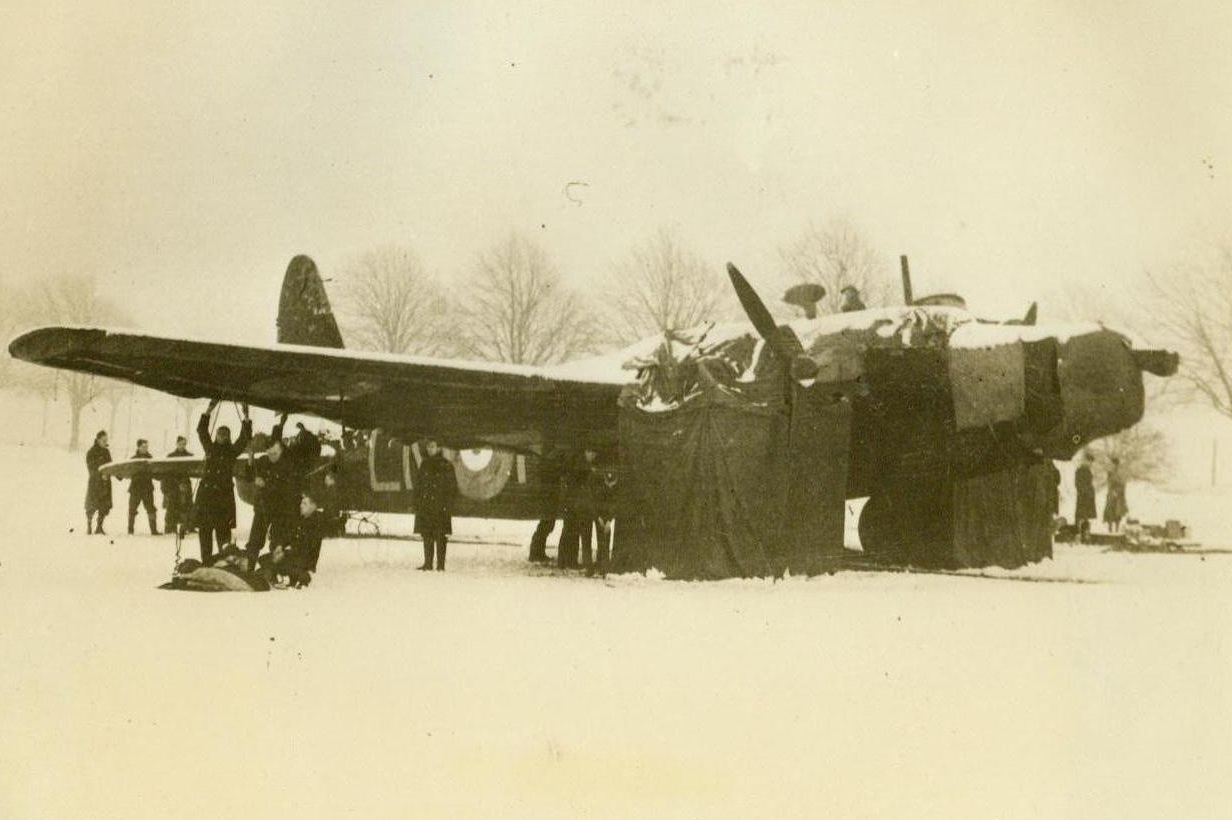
779, 218, 892, 313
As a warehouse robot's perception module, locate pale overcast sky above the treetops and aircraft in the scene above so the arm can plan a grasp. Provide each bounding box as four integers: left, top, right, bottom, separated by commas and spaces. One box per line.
0, 0, 1232, 340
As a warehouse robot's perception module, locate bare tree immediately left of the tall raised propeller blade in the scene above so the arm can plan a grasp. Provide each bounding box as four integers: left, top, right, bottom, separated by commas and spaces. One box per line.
600, 228, 734, 344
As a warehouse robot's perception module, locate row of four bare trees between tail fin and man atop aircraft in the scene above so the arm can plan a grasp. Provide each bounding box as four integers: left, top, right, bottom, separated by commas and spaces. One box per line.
334, 219, 893, 364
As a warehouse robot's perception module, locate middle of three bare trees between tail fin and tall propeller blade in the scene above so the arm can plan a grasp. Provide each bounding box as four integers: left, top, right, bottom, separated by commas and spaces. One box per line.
455, 234, 599, 364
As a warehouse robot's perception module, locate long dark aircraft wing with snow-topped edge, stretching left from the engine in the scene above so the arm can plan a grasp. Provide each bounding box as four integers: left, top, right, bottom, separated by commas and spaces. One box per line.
9, 326, 627, 451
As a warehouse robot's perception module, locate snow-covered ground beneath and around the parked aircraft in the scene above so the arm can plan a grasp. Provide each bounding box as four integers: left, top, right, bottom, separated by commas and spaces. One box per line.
7, 446, 1232, 819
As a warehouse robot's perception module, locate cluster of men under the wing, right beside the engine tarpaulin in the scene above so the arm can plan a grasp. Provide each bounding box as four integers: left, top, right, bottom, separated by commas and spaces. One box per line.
530, 448, 616, 575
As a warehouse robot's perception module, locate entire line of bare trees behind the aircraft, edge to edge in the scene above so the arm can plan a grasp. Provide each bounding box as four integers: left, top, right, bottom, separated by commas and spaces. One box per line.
0, 218, 1232, 480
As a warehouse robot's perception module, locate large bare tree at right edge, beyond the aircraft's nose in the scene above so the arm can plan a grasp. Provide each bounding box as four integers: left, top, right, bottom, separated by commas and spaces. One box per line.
1137, 245, 1232, 419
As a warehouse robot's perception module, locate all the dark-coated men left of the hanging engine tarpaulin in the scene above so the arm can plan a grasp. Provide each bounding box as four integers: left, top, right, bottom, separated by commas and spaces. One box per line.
86, 400, 616, 573
